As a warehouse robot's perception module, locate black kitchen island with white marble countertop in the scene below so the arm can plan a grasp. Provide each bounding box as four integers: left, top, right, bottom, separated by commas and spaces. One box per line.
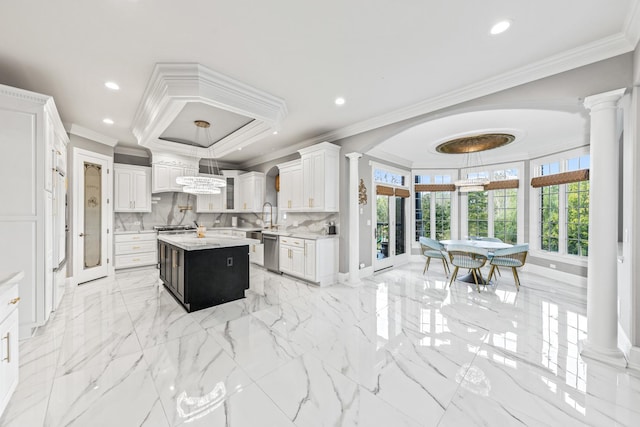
158, 233, 259, 312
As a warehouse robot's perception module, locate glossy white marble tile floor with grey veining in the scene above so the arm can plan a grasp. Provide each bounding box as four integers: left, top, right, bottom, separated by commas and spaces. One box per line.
0, 263, 640, 427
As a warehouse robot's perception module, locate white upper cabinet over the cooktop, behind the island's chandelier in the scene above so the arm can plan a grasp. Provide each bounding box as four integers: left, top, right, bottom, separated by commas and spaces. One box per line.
151, 153, 199, 193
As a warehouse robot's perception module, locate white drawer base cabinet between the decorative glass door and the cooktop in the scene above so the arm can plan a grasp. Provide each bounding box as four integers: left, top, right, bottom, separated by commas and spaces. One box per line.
114, 232, 158, 269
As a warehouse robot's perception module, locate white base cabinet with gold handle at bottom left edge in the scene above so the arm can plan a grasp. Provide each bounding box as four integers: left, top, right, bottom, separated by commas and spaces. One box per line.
0, 274, 21, 418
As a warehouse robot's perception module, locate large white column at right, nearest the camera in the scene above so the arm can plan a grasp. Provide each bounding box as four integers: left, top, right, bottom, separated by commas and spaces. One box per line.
580, 89, 626, 366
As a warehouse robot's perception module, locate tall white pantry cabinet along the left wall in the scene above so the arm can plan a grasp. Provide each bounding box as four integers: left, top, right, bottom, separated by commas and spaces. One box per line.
0, 85, 69, 339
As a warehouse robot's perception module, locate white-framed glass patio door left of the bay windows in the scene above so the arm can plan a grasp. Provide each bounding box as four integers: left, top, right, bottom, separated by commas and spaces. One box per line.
373, 194, 409, 271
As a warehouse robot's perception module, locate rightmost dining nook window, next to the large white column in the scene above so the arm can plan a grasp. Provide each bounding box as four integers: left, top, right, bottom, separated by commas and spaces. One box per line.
536, 151, 590, 257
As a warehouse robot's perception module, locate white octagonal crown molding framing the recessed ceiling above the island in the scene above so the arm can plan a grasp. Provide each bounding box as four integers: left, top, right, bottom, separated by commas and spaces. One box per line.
132, 63, 287, 157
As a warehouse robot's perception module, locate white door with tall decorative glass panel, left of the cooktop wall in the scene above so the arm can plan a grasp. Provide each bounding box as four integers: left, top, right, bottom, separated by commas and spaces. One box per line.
73, 150, 111, 283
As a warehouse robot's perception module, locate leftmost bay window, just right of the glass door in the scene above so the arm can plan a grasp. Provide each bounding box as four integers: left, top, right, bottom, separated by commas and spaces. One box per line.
415, 174, 452, 241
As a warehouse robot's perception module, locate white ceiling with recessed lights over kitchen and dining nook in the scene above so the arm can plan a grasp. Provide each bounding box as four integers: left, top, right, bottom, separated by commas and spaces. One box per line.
0, 0, 640, 166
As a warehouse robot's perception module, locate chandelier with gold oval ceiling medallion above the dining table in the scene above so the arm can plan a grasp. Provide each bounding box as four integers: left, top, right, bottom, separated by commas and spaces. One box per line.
436, 133, 515, 193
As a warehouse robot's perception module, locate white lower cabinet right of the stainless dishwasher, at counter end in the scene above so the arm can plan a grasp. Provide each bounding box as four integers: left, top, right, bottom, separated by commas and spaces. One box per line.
280, 237, 338, 286
